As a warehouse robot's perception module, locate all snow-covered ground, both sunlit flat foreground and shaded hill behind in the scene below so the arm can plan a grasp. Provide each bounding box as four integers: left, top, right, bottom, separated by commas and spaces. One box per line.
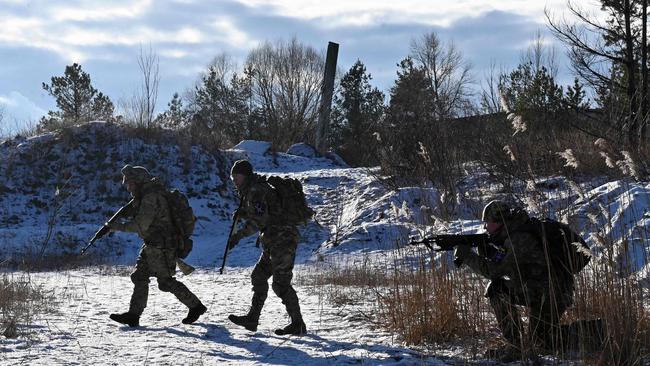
0, 123, 650, 365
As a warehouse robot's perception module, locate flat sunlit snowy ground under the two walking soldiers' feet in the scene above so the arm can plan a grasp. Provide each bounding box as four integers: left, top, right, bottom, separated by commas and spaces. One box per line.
0, 268, 450, 365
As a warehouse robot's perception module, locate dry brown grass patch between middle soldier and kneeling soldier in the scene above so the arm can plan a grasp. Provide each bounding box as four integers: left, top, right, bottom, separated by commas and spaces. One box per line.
301, 251, 491, 345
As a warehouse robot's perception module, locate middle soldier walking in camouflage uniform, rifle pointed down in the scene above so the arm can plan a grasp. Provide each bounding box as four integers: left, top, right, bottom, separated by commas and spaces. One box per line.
228, 160, 307, 335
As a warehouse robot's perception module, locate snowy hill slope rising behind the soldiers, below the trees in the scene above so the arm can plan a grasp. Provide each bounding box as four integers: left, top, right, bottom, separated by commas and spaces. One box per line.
0, 122, 650, 273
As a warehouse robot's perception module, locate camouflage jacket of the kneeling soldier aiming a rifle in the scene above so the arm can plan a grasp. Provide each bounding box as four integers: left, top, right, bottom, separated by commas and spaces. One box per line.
463, 211, 573, 297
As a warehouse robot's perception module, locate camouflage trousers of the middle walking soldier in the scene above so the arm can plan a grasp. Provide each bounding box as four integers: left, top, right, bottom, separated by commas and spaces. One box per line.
249, 228, 302, 320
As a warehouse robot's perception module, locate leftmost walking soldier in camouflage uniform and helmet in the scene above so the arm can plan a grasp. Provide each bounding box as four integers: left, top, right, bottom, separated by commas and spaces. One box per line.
108, 165, 207, 327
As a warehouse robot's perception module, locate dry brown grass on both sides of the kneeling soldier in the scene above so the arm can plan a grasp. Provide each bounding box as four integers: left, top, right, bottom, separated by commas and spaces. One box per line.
302, 236, 650, 365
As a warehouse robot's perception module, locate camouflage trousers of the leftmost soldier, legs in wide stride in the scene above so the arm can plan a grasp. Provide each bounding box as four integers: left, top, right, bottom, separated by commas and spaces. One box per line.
129, 245, 201, 315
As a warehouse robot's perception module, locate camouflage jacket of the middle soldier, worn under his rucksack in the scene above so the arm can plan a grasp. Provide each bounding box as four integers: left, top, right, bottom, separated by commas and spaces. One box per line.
237, 174, 285, 237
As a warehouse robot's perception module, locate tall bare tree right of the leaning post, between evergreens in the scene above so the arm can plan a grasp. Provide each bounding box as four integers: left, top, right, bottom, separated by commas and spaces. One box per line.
410, 32, 472, 120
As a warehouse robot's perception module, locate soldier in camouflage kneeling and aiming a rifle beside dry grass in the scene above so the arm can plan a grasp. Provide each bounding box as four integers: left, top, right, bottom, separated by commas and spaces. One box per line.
454, 201, 574, 362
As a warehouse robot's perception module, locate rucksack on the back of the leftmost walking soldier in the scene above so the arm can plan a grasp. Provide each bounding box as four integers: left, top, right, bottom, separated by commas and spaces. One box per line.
164, 189, 196, 258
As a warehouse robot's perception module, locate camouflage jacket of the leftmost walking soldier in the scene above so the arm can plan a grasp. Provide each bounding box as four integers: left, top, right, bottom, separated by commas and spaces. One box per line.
110, 178, 175, 247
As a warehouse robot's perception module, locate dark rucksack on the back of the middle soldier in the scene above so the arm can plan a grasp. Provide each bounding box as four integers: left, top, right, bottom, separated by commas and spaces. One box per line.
266, 176, 315, 225
